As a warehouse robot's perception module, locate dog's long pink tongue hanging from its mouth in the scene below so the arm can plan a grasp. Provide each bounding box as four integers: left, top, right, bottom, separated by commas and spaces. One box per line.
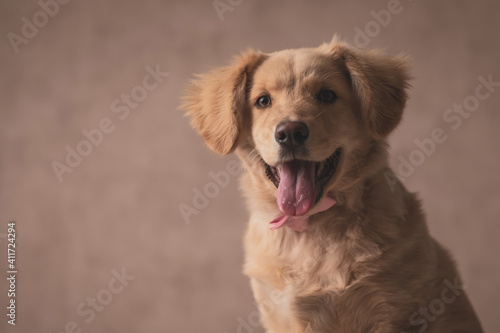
277, 161, 316, 216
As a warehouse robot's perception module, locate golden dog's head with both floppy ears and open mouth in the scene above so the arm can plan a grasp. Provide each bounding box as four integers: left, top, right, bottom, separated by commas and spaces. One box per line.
184, 38, 408, 216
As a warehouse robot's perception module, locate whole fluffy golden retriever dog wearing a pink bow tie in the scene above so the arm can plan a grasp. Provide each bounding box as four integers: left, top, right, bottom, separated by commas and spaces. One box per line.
183, 38, 482, 333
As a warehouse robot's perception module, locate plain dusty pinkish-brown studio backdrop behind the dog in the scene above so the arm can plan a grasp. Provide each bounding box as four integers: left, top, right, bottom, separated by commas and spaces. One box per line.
0, 0, 500, 333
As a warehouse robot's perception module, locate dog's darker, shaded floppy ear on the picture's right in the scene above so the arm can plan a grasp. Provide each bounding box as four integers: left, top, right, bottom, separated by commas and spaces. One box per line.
332, 38, 410, 139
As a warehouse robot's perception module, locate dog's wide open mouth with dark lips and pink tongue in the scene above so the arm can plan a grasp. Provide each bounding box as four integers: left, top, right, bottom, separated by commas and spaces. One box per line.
265, 148, 342, 216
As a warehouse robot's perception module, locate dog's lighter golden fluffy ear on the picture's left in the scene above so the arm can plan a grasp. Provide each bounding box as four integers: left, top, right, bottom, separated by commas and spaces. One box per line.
181, 50, 266, 155
